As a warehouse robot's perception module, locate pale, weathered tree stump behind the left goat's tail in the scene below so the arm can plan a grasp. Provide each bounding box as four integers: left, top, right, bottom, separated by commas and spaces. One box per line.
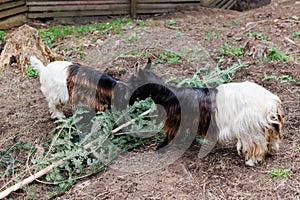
0, 25, 59, 72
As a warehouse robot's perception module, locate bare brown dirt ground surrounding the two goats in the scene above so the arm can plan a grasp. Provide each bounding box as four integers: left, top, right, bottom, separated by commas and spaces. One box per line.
0, 0, 300, 199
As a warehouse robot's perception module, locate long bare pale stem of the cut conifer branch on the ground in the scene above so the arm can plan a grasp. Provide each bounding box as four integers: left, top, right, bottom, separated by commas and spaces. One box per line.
0, 109, 152, 199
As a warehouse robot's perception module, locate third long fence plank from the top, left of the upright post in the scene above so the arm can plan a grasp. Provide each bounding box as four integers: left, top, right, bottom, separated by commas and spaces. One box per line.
28, 7, 130, 19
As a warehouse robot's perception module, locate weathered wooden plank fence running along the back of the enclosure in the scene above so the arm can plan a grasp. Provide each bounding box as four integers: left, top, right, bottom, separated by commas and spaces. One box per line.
0, 0, 235, 29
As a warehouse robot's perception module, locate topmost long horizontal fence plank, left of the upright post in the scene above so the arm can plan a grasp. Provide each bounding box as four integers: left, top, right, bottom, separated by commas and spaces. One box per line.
27, 0, 130, 6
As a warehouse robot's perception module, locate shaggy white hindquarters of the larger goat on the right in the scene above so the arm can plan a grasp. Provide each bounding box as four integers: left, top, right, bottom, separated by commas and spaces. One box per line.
216, 82, 282, 166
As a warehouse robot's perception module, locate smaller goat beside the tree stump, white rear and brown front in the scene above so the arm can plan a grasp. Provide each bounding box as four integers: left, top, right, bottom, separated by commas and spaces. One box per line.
30, 56, 127, 118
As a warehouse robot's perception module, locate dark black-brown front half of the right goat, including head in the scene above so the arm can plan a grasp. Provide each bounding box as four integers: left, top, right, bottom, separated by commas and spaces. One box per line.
129, 69, 217, 149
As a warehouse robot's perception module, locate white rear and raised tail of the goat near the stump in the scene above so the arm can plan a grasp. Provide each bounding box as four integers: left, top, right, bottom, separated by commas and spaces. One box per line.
30, 56, 72, 118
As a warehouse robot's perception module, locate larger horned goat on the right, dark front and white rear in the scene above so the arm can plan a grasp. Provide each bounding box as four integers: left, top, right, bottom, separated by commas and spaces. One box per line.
127, 59, 283, 166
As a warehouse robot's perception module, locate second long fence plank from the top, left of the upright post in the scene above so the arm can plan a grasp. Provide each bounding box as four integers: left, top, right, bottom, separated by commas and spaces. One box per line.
29, 4, 129, 12
